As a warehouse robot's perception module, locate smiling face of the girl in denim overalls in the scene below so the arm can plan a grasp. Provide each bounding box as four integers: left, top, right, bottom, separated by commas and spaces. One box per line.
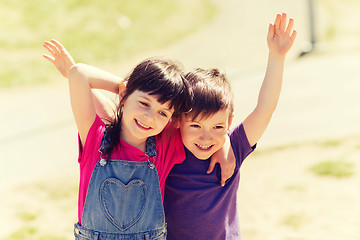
120, 90, 174, 148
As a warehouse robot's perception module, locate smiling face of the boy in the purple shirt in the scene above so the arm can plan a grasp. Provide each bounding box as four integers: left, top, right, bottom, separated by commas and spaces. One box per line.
180, 110, 232, 160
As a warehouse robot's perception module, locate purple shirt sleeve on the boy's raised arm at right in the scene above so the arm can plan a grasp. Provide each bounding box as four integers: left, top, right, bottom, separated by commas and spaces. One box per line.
229, 124, 256, 166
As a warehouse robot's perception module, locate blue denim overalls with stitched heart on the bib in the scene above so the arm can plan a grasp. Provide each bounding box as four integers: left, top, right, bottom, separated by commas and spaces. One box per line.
74, 129, 166, 240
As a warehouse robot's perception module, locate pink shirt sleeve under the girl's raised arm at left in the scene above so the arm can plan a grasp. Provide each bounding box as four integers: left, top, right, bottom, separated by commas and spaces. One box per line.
78, 115, 105, 167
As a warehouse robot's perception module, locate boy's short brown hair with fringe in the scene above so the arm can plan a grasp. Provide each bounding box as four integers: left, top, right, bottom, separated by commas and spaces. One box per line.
185, 68, 234, 120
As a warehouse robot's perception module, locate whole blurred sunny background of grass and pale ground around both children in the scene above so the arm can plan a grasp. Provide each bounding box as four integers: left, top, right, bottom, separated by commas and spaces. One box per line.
0, 0, 360, 240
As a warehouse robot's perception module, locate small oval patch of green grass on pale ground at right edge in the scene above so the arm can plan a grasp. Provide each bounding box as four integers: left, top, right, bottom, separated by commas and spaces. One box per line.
310, 160, 355, 178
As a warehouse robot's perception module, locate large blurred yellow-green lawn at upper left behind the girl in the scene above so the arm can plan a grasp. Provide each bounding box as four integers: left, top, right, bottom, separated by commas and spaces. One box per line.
0, 0, 216, 87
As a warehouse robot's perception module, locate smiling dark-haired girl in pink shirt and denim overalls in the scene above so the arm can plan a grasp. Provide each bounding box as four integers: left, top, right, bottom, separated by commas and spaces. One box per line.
44, 40, 189, 239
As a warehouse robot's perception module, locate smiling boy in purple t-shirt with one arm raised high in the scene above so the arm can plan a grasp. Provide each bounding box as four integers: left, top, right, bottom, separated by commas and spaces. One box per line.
164, 13, 296, 240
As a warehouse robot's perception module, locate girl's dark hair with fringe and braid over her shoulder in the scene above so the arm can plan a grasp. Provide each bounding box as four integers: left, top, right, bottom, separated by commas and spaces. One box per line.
103, 57, 190, 158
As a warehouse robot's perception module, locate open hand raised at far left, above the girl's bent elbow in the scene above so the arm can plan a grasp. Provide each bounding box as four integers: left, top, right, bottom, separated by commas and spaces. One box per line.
43, 39, 75, 78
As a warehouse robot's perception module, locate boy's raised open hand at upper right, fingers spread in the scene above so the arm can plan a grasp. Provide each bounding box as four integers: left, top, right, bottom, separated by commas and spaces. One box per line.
267, 13, 297, 57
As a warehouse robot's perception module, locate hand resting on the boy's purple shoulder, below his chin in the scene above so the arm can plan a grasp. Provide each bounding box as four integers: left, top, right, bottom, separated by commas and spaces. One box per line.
207, 136, 236, 186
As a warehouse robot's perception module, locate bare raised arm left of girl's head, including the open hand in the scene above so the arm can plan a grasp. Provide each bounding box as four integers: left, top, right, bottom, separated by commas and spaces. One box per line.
44, 40, 122, 145
